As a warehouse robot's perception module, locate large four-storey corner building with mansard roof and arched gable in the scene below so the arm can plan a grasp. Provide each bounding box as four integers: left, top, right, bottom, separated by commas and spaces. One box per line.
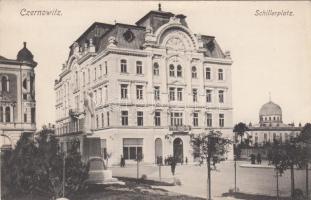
55, 8, 233, 164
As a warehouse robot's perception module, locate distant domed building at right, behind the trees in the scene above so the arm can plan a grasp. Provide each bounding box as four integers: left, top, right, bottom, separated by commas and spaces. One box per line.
248, 101, 302, 146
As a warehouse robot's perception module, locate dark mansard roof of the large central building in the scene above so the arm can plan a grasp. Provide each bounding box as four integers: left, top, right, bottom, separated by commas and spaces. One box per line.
69, 9, 226, 59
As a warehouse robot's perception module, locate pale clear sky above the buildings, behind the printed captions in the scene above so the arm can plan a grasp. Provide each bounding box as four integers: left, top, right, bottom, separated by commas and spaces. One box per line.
0, 0, 311, 128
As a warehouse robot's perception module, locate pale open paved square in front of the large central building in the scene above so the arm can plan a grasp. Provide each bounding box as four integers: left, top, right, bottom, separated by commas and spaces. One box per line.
111, 161, 311, 199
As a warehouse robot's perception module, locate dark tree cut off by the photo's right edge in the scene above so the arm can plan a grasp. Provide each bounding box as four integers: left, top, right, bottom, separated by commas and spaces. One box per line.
298, 123, 311, 199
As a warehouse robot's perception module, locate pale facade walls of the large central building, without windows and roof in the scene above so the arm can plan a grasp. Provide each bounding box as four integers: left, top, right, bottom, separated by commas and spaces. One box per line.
55, 15, 233, 164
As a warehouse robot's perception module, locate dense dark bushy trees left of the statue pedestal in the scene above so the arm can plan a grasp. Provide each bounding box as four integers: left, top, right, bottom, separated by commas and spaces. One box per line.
2, 128, 88, 197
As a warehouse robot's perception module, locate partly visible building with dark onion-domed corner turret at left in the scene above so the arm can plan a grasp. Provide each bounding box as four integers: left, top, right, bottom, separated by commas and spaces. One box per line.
0, 42, 37, 148
